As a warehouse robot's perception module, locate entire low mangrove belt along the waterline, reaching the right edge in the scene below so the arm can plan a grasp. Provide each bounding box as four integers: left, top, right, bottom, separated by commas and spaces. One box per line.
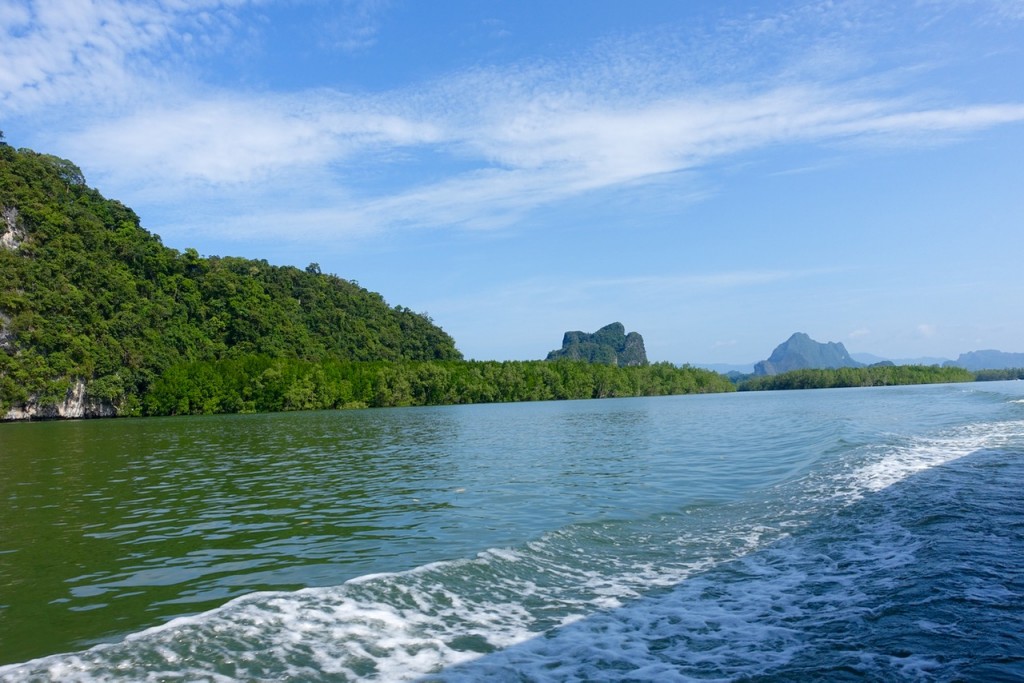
0, 354, 1007, 420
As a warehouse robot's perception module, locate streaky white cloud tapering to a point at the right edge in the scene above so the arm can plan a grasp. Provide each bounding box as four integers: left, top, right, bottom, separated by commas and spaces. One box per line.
339, 87, 1024, 235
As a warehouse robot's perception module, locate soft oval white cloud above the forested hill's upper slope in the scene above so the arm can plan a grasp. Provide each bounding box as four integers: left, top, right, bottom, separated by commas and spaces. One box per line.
65, 93, 438, 185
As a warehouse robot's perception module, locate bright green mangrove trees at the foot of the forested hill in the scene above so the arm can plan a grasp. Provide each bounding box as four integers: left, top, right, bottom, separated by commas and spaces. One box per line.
142, 354, 734, 415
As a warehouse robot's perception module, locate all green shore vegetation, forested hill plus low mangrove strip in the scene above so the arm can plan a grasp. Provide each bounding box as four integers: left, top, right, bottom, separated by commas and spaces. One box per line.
0, 140, 1024, 421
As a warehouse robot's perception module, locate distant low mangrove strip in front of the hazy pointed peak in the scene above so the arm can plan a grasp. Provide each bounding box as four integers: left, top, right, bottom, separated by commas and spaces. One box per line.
737, 366, 975, 391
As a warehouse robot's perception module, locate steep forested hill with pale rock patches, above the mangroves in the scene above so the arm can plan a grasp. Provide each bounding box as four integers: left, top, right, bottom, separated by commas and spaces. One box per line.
0, 137, 461, 418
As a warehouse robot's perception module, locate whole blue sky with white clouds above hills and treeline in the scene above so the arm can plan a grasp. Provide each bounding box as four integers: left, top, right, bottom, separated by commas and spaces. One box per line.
0, 0, 1024, 365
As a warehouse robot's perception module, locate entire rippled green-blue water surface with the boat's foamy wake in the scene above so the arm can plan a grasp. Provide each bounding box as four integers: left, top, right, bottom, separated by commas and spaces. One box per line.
0, 382, 1024, 681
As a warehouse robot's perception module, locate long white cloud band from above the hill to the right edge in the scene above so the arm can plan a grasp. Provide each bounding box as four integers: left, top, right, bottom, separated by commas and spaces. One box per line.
94, 79, 1024, 239
